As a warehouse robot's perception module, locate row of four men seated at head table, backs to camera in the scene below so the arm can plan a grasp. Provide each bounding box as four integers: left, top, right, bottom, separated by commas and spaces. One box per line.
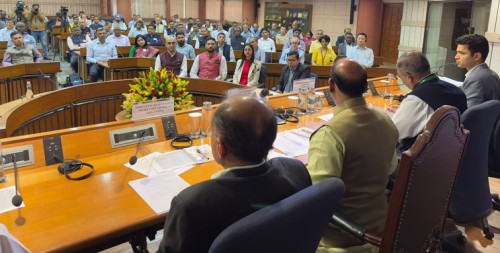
145, 35, 500, 252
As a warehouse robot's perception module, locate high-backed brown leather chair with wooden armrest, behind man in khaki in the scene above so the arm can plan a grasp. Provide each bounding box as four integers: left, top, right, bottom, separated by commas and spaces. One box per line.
332, 106, 469, 253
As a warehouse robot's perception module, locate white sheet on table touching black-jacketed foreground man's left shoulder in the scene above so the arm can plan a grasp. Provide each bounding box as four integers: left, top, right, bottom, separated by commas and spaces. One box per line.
128, 171, 189, 214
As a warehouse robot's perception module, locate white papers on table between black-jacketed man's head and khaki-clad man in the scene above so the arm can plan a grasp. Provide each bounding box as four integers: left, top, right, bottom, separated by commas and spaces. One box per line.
273, 131, 309, 157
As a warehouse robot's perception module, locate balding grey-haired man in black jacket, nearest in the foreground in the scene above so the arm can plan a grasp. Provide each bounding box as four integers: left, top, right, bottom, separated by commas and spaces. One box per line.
158, 97, 311, 253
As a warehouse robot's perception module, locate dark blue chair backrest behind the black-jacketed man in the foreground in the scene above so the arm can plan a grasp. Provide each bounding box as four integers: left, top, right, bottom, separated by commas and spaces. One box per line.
209, 178, 344, 253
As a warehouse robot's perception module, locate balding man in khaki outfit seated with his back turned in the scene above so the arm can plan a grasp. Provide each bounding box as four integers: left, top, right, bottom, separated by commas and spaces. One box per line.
307, 59, 398, 253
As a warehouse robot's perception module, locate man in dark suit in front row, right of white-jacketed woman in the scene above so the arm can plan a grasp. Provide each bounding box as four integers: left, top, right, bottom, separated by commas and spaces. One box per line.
276, 51, 311, 93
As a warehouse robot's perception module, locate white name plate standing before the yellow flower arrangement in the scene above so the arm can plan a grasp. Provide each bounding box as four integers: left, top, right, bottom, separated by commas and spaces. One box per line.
132, 98, 174, 120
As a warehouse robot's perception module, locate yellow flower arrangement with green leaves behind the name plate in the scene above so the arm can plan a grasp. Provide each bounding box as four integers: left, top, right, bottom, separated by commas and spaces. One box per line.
122, 68, 194, 118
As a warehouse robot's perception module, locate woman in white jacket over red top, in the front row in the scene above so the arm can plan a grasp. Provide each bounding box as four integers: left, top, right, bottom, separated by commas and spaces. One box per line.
233, 44, 262, 86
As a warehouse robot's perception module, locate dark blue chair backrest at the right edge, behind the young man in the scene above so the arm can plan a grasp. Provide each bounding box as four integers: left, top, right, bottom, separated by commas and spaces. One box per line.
450, 100, 500, 220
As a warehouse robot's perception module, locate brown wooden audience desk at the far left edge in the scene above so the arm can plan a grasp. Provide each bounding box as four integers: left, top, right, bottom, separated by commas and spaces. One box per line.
0, 62, 61, 104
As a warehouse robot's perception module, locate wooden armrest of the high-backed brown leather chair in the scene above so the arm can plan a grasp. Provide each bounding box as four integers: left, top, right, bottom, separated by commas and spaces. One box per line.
330, 210, 381, 247
